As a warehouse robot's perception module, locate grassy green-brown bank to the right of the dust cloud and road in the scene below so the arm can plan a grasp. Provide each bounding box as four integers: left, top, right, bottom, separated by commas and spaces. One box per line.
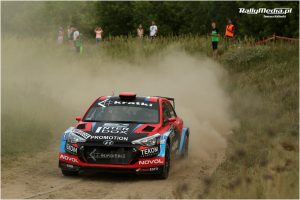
205, 44, 299, 198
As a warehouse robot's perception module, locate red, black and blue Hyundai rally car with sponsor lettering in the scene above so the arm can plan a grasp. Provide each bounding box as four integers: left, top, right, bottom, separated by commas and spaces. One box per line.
59, 92, 189, 179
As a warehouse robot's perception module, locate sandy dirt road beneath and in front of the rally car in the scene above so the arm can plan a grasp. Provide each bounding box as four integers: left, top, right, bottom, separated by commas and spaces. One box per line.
2, 137, 223, 198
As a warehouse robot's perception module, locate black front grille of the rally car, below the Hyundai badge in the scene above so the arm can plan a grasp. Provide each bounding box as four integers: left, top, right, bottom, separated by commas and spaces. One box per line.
82, 146, 137, 165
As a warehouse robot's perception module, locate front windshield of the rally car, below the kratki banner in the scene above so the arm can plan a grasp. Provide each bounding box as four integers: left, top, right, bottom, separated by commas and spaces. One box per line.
83, 105, 159, 124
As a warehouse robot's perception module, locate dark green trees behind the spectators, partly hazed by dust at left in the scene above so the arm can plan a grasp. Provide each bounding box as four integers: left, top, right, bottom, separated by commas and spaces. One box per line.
1, 1, 299, 38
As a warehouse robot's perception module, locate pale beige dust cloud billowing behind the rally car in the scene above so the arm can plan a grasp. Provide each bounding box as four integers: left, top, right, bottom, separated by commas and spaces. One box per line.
2, 41, 236, 162
